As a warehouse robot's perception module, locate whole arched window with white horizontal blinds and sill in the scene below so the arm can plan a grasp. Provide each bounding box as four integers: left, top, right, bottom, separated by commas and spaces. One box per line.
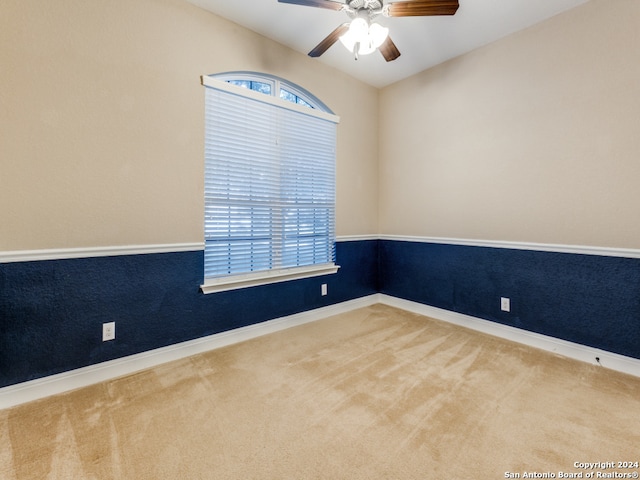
202, 73, 339, 293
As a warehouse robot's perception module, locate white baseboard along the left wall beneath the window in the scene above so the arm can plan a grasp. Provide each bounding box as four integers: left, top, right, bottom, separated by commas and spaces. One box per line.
0, 294, 378, 409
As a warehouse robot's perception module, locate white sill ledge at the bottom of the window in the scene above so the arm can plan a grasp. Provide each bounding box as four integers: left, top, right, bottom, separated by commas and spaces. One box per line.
200, 263, 340, 294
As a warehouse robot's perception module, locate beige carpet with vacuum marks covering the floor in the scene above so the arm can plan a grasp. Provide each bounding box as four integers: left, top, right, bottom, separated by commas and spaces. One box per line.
0, 305, 640, 480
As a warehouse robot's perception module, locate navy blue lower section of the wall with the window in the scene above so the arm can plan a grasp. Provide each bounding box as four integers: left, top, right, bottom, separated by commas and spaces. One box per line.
0, 240, 378, 387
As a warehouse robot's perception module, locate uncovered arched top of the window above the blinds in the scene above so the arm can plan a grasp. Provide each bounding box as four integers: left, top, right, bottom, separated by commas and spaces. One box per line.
209, 71, 333, 114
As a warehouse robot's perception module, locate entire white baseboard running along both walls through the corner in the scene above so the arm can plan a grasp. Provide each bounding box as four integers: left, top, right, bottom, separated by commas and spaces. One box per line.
0, 293, 640, 409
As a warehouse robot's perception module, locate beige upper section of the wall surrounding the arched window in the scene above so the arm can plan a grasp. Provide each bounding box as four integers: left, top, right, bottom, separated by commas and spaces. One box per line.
0, 0, 378, 251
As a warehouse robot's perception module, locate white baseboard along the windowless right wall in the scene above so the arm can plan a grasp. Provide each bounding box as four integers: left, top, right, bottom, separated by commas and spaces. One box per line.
379, 294, 640, 377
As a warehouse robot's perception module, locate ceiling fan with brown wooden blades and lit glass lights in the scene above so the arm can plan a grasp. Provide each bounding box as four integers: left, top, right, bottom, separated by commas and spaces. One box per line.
278, 0, 459, 62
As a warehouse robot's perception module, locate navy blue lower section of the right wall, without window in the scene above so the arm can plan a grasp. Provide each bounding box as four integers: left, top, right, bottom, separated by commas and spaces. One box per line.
379, 240, 640, 359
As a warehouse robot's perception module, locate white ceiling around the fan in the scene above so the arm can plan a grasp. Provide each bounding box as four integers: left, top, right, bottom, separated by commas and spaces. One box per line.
188, 0, 589, 88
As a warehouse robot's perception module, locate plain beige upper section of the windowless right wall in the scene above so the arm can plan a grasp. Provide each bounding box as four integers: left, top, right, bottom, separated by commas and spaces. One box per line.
379, 0, 640, 248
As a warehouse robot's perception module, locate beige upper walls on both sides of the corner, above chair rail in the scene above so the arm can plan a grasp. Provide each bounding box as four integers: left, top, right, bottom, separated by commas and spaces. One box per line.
6, 0, 640, 251
